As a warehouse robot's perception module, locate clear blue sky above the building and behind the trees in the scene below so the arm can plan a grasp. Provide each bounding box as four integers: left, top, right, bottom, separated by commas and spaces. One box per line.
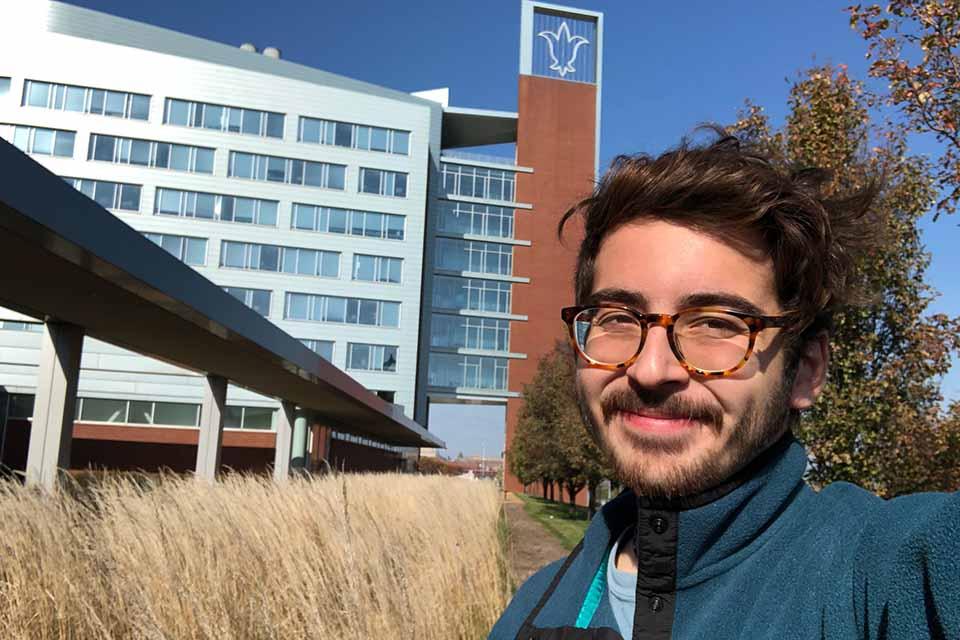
63, 0, 960, 454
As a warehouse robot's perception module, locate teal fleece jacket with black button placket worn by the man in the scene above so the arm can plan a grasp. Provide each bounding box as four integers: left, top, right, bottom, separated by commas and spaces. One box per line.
489, 436, 960, 640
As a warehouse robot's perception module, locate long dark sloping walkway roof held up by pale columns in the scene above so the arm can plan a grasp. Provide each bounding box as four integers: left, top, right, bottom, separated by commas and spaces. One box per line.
0, 140, 444, 448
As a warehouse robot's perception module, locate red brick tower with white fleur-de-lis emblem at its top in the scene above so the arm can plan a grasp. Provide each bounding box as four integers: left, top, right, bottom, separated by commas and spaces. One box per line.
504, 0, 603, 491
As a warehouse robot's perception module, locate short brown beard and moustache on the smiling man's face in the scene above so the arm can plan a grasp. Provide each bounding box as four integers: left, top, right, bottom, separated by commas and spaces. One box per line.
577, 376, 796, 498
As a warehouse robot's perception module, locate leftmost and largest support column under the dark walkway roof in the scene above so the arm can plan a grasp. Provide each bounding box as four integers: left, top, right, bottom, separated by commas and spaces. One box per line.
27, 322, 83, 491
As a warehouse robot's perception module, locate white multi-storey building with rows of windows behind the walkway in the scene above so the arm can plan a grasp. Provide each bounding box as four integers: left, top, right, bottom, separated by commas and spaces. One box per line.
0, 0, 568, 470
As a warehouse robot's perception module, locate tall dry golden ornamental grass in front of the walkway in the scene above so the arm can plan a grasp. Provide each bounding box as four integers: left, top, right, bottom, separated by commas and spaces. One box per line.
0, 475, 510, 640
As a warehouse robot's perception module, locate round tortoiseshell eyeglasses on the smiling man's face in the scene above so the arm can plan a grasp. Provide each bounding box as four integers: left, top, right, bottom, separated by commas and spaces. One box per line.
560, 304, 794, 378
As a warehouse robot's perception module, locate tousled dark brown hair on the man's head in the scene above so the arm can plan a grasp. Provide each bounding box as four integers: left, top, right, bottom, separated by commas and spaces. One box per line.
558, 127, 880, 336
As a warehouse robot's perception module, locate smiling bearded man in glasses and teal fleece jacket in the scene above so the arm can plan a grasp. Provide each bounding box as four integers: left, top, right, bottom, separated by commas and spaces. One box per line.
490, 132, 960, 640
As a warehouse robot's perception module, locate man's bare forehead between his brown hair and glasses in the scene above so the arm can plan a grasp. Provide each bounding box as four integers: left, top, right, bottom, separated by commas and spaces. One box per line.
591, 220, 779, 312
